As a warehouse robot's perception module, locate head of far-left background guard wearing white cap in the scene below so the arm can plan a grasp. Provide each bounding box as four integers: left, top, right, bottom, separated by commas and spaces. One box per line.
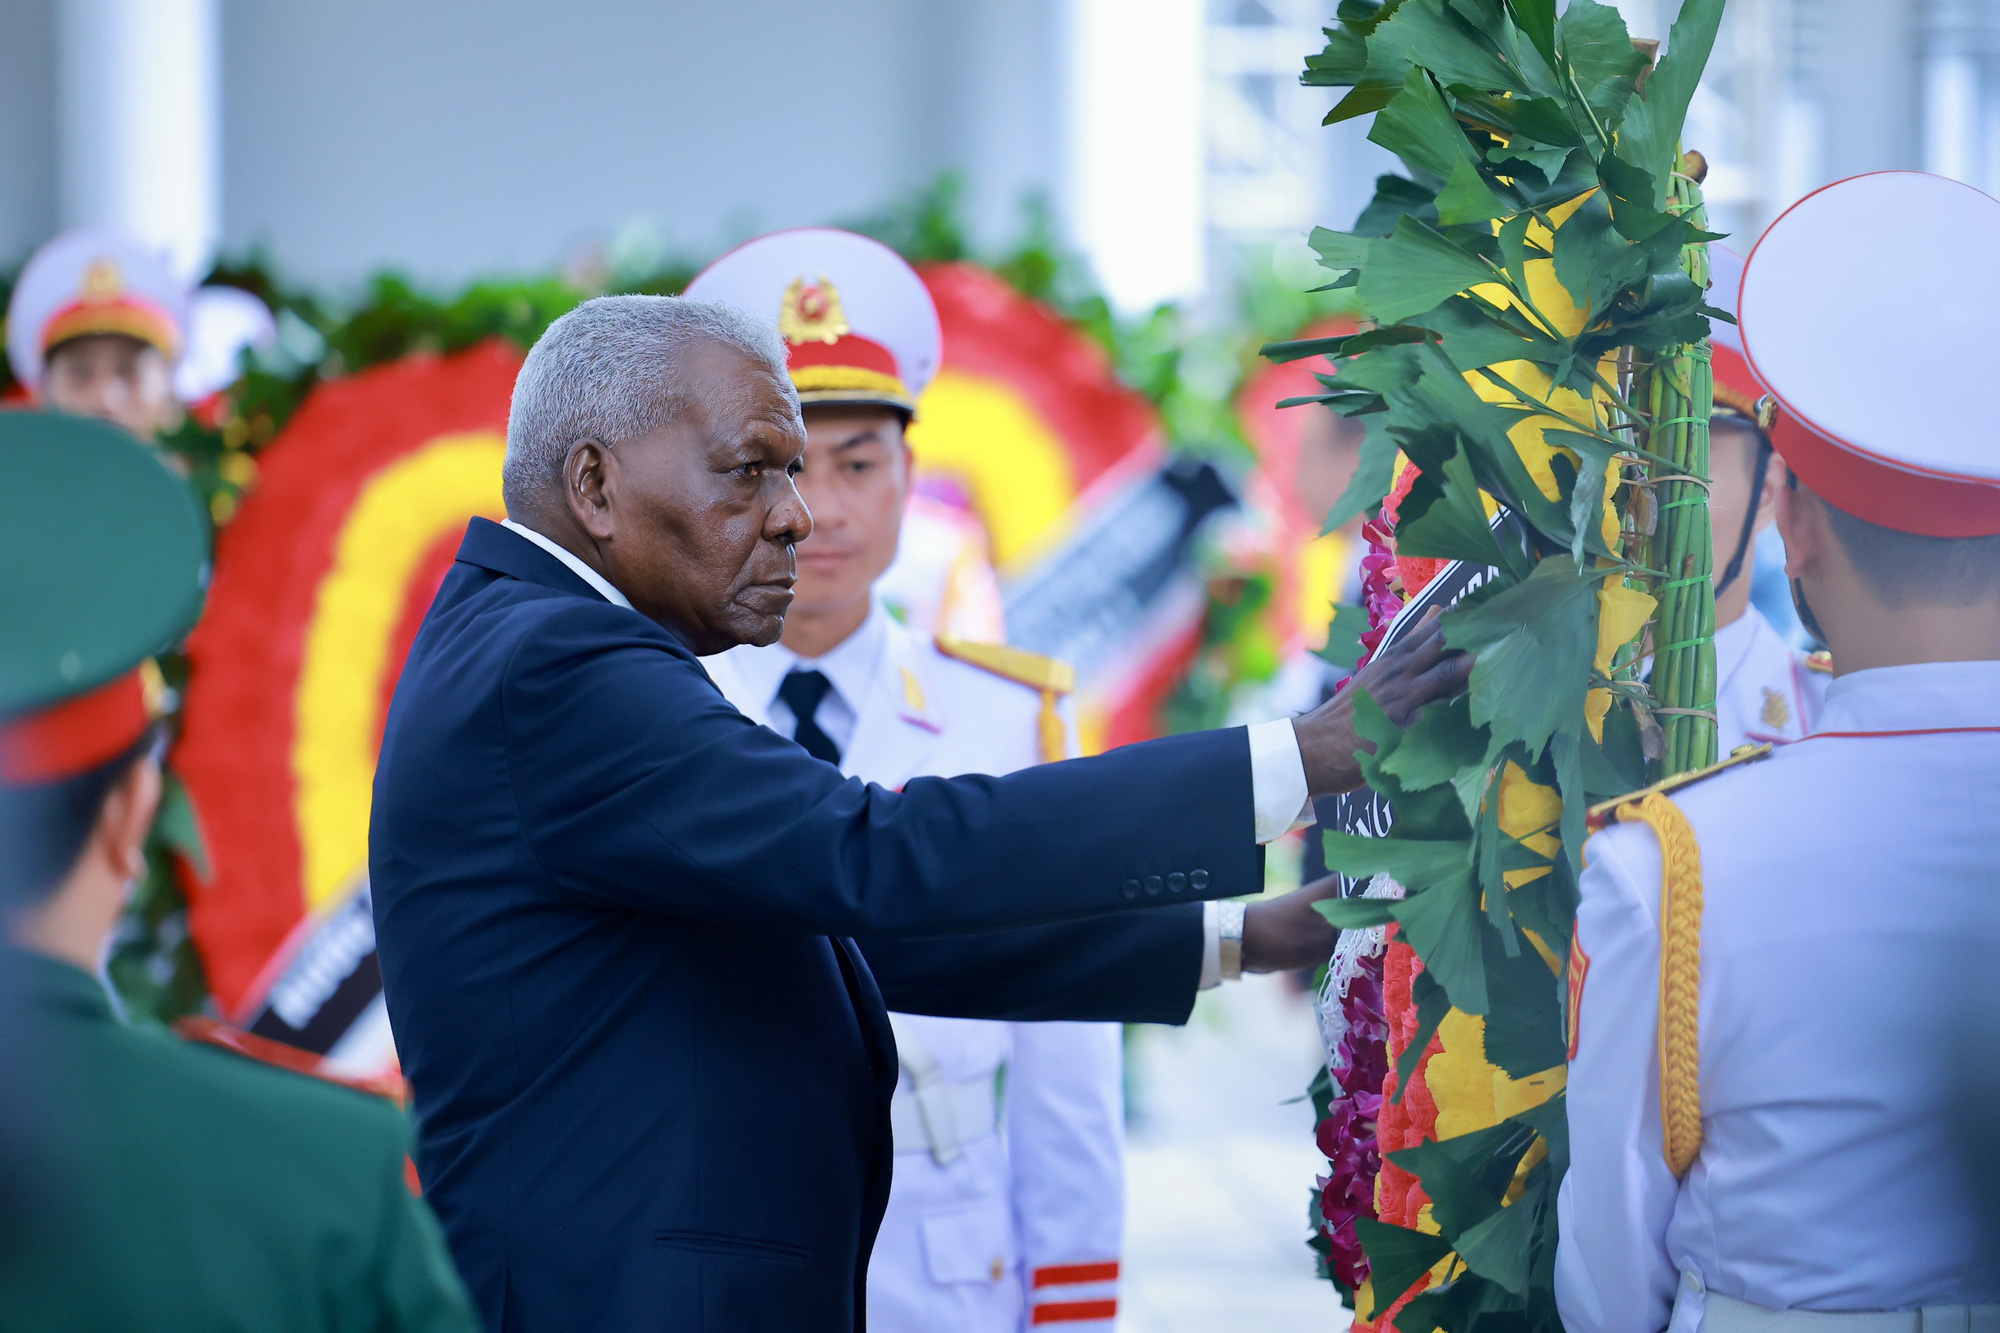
6, 228, 192, 440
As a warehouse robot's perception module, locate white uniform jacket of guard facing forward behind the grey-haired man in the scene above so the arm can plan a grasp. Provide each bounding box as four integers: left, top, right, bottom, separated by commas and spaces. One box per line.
706, 608, 1124, 1333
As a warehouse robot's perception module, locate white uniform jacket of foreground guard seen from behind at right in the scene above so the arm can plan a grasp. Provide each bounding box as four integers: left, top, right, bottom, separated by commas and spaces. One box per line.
1556, 662, 2000, 1333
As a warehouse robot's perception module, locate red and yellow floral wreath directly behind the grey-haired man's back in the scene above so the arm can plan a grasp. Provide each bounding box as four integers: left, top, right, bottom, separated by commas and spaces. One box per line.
174, 342, 520, 1015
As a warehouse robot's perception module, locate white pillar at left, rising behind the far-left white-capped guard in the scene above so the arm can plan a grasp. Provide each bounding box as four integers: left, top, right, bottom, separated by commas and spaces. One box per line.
56, 0, 222, 278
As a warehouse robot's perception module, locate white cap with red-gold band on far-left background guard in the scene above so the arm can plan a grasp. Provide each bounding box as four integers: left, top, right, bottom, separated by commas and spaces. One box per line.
6, 228, 188, 388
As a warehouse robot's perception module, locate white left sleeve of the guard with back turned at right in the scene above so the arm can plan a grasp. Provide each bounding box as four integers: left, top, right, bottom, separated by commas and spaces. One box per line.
1556, 829, 1680, 1333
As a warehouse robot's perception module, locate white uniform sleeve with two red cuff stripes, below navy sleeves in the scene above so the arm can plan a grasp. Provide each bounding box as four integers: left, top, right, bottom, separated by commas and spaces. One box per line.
1006, 1023, 1124, 1329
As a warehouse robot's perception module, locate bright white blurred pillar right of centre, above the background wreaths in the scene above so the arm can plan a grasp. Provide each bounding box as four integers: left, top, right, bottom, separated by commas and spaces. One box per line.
1070, 0, 1206, 310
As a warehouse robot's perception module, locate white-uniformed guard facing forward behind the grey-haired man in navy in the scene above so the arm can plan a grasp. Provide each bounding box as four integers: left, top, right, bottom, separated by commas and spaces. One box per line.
688, 228, 1200, 1333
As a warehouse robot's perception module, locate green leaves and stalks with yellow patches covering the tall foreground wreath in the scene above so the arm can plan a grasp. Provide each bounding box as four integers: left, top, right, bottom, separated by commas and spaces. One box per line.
1266, 0, 1728, 1333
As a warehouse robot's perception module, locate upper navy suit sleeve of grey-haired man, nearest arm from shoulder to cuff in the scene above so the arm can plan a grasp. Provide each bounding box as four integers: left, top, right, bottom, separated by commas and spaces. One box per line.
502, 600, 1262, 937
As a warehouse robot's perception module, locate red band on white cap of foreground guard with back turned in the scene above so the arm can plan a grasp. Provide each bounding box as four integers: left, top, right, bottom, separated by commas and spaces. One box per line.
1770, 402, 2000, 536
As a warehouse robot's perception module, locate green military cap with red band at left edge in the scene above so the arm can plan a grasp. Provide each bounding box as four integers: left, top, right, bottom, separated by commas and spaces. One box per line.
0, 412, 208, 752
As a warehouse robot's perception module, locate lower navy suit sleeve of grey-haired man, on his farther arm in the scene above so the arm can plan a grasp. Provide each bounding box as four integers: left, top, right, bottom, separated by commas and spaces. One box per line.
856, 903, 1202, 1025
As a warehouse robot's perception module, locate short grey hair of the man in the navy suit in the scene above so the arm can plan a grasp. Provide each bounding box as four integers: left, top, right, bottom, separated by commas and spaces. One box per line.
500, 296, 792, 504
